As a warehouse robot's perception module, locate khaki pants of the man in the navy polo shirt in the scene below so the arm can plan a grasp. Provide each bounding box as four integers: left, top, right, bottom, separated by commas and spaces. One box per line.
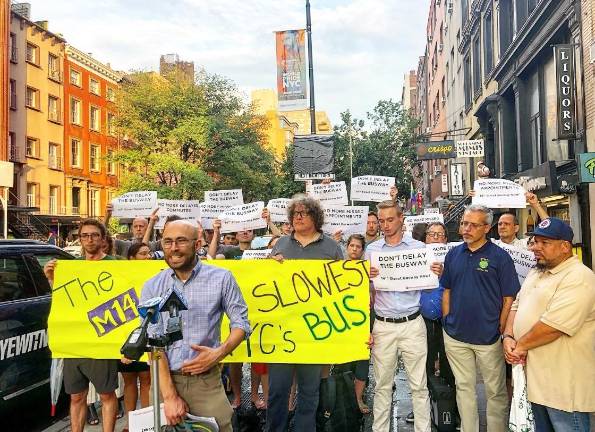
444, 332, 508, 432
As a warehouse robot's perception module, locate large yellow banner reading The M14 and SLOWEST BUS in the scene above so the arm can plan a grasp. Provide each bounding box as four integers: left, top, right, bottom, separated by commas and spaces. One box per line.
48, 260, 370, 364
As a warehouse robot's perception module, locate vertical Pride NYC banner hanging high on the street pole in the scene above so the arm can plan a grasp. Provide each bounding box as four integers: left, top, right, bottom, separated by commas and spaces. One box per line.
275, 29, 308, 111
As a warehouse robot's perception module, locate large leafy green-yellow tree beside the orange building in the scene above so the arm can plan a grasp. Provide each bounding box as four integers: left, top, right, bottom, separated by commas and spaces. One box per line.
115, 72, 275, 200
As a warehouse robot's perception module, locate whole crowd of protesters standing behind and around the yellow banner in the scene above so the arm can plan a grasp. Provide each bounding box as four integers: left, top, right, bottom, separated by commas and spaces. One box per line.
45, 189, 595, 432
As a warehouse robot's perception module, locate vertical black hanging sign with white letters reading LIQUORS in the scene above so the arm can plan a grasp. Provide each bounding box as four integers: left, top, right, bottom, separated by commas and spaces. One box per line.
554, 44, 576, 139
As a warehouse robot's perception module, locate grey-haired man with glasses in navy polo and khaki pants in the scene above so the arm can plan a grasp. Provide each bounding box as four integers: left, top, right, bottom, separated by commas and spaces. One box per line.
440, 205, 520, 432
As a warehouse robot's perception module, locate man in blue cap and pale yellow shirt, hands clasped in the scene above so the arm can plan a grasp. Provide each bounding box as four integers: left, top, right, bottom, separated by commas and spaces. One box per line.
503, 217, 595, 432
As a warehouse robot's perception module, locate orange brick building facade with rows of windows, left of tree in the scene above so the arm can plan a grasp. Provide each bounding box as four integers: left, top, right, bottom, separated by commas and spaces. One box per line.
64, 45, 122, 217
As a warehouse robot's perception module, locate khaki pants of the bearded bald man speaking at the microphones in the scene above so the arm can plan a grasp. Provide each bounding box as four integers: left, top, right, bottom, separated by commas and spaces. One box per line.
159, 367, 233, 432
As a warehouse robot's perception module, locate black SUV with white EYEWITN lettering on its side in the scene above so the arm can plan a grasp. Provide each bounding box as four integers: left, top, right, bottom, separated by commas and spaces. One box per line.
0, 240, 73, 412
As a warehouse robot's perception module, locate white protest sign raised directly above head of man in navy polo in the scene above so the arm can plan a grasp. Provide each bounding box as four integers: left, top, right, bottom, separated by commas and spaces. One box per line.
471, 179, 527, 208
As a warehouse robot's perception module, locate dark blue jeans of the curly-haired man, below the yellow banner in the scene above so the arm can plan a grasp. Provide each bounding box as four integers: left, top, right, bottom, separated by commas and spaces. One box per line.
266, 363, 322, 432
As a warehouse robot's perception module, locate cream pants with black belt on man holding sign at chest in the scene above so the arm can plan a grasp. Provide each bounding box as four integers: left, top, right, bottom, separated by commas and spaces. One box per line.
372, 316, 430, 432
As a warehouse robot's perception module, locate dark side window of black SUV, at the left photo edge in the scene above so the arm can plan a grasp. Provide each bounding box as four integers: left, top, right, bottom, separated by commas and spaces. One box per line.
0, 257, 37, 302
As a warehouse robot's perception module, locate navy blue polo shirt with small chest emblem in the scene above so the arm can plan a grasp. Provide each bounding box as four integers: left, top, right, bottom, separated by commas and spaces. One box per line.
440, 241, 520, 345
